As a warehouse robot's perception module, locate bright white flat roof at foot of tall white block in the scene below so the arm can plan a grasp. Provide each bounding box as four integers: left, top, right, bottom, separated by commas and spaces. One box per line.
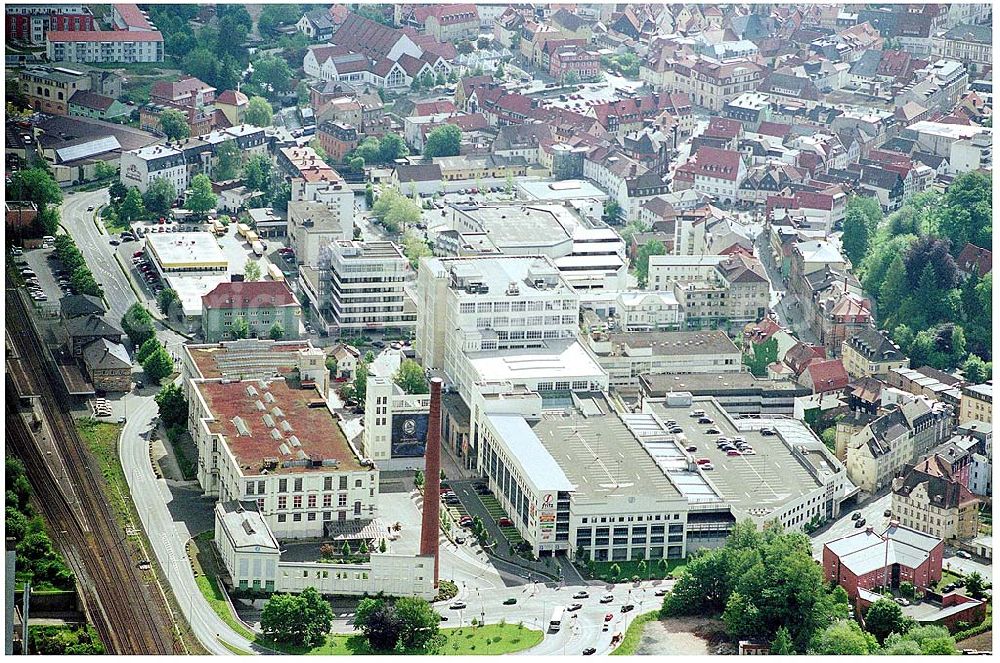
466, 340, 604, 383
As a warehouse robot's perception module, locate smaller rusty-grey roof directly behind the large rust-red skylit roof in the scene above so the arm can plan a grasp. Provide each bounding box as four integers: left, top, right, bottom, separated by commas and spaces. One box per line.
183, 338, 312, 380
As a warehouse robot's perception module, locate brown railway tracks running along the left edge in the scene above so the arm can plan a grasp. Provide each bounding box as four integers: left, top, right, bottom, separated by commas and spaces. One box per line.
6, 289, 177, 655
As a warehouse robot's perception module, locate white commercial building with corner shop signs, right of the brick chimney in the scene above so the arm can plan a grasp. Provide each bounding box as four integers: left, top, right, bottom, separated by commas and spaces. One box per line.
481, 392, 687, 561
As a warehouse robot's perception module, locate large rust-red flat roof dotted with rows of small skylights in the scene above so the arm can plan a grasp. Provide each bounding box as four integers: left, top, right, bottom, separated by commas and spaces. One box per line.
194, 379, 365, 475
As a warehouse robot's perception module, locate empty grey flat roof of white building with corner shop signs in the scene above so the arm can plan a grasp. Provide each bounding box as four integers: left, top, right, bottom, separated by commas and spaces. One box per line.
529, 393, 681, 498
